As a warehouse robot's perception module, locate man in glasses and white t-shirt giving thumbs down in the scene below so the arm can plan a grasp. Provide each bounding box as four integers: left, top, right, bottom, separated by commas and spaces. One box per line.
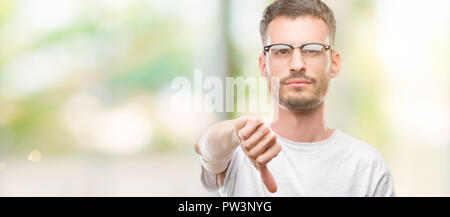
195, 0, 395, 196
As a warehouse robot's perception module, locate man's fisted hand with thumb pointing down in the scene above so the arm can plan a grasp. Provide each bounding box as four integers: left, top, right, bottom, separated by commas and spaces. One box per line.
234, 116, 281, 193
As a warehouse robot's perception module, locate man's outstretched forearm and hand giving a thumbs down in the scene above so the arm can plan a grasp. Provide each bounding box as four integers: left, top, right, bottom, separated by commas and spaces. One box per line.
195, 116, 281, 193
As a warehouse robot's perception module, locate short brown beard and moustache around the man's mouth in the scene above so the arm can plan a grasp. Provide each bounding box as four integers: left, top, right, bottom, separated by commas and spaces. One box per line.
271, 72, 329, 111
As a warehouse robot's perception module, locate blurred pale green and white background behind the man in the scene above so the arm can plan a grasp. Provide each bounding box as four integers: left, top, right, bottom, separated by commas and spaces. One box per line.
0, 0, 450, 196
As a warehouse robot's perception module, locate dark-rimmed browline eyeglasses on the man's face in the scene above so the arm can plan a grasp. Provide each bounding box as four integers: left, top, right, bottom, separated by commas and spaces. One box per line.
264, 43, 331, 67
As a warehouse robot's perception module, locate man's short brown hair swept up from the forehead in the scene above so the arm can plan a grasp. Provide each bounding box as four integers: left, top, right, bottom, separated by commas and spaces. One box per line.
259, 0, 336, 44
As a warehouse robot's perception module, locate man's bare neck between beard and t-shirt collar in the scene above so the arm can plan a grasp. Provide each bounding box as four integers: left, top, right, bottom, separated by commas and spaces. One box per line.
272, 103, 334, 142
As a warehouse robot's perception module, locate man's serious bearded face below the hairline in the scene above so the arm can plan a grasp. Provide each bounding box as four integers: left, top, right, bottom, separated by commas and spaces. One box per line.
260, 16, 340, 110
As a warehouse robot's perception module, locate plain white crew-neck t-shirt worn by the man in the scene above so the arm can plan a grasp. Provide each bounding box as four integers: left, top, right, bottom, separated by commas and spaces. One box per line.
201, 129, 395, 197
